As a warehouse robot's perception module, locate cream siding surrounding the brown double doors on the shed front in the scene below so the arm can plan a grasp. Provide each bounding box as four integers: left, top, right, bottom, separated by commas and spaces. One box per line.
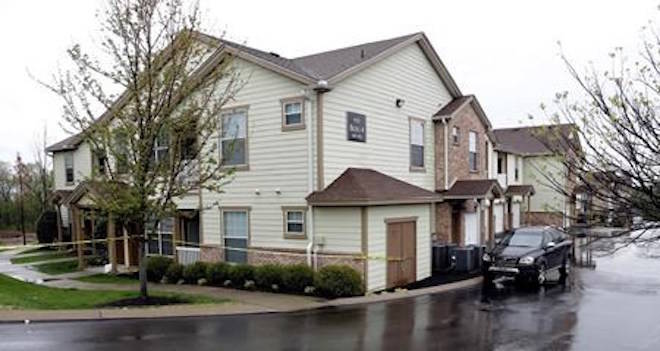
367, 205, 431, 291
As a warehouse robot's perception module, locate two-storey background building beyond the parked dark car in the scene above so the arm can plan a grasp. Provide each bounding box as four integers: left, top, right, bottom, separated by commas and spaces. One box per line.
493, 124, 579, 228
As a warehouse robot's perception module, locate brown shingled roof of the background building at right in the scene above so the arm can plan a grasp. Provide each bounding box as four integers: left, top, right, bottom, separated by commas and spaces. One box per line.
493, 124, 579, 156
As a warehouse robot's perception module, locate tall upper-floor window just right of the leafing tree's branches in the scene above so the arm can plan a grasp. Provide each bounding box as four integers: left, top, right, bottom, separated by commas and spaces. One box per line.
220, 109, 248, 166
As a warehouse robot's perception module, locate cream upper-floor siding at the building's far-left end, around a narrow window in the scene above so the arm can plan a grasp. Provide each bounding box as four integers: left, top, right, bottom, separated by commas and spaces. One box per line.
53, 143, 92, 190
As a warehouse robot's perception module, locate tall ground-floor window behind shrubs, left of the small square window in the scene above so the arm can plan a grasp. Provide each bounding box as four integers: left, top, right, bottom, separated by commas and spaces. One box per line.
222, 210, 249, 263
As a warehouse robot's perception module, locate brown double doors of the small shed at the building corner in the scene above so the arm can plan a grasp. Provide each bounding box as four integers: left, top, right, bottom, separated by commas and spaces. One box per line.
387, 221, 417, 288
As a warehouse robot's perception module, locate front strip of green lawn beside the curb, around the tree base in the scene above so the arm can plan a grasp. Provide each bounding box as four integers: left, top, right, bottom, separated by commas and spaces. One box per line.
0, 274, 227, 310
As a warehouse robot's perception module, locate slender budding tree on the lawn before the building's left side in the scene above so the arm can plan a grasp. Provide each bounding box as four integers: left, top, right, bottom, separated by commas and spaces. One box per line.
48, 0, 243, 298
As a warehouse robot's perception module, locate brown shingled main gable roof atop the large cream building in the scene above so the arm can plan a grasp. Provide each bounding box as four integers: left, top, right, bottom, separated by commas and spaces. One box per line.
46, 32, 462, 152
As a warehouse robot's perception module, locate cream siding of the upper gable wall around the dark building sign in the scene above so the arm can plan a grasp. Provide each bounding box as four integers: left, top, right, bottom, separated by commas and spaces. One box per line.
323, 44, 451, 190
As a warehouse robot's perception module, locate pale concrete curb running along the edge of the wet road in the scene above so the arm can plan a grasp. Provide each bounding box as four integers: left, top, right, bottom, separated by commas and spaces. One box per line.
0, 277, 482, 323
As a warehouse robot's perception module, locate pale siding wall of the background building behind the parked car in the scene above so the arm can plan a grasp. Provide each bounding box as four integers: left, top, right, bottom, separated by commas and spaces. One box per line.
523, 156, 566, 212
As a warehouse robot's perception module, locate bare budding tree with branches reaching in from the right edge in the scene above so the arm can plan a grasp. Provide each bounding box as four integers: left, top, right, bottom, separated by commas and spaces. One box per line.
539, 22, 660, 248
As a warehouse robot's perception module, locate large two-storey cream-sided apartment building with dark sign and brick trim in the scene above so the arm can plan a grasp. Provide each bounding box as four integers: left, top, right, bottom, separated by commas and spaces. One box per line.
47, 33, 504, 291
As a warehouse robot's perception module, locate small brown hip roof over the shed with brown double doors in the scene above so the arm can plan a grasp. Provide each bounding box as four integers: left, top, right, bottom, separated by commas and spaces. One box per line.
306, 168, 441, 206
